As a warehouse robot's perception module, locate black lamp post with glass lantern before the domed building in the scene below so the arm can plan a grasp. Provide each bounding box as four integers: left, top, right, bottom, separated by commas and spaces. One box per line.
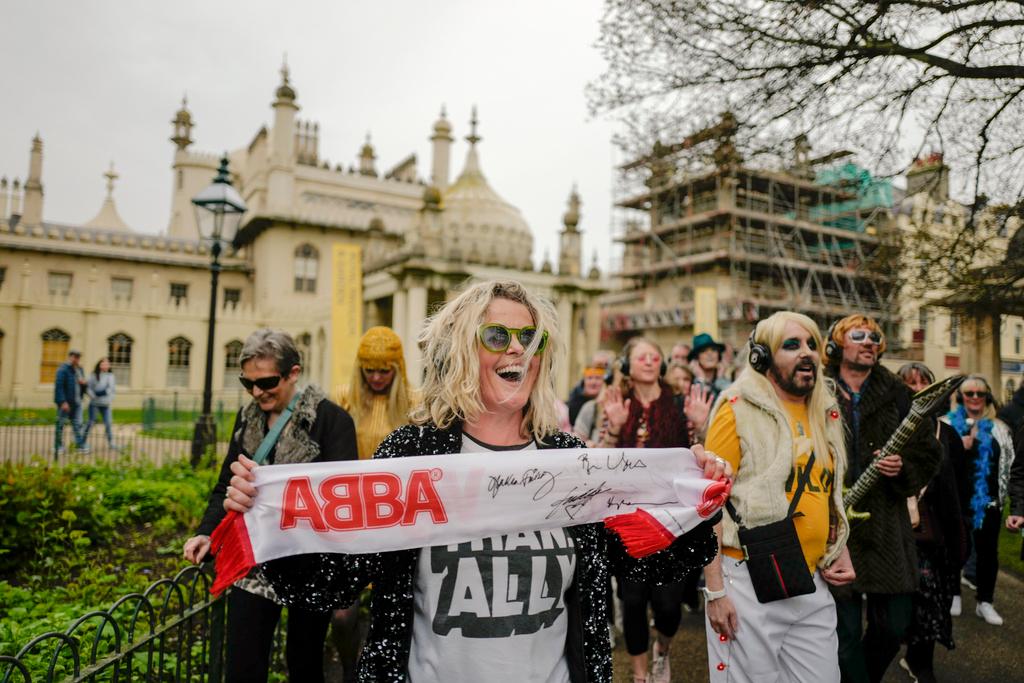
191, 155, 246, 467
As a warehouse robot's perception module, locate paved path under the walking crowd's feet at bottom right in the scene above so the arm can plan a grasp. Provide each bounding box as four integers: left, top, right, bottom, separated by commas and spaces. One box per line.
614, 572, 1024, 683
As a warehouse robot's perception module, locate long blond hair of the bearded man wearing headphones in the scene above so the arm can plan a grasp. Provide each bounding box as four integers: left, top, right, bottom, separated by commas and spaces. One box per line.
743, 310, 846, 463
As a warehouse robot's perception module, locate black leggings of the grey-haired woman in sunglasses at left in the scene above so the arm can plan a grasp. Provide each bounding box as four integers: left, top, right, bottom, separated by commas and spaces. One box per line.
225, 588, 331, 683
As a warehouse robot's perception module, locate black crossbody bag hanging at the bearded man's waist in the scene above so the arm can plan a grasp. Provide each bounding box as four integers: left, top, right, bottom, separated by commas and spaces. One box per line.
725, 453, 816, 602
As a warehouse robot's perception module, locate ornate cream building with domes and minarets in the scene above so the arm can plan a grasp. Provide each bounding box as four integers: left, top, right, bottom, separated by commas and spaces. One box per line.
0, 67, 603, 407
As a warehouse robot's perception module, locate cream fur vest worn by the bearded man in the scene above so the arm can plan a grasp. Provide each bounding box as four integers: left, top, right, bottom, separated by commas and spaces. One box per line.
709, 369, 850, 567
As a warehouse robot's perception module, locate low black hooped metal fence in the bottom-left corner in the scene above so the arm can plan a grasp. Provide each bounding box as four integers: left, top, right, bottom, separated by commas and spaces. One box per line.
0, 567, 226, 683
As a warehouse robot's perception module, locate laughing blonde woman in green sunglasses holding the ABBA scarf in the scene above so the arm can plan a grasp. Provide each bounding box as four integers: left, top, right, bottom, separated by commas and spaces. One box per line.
227, 281, 725, 683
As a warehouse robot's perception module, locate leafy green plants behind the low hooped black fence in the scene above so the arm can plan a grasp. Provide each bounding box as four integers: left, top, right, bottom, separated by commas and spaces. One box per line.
0, 462, 217, 654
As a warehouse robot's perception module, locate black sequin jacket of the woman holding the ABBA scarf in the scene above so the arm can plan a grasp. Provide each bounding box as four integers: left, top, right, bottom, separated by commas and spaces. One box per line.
262, 425, 718, 683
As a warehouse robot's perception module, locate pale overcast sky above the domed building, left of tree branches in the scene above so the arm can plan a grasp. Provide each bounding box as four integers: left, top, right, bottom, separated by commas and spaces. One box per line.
0, 0, 617, 268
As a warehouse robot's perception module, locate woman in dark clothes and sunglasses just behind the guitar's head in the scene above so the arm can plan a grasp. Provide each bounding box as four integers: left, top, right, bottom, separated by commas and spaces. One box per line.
896, 362, 967, 683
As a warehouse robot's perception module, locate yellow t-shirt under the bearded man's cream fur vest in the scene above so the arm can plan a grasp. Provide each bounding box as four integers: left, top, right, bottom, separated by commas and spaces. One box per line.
705, 400, 836, 572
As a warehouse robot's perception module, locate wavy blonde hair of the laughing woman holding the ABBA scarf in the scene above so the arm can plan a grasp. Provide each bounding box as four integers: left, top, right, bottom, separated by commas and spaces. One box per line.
411, 280, 565, 440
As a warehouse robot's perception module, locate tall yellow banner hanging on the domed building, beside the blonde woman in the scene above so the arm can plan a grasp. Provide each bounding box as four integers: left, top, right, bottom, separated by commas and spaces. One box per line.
331, 245, 362, 391
